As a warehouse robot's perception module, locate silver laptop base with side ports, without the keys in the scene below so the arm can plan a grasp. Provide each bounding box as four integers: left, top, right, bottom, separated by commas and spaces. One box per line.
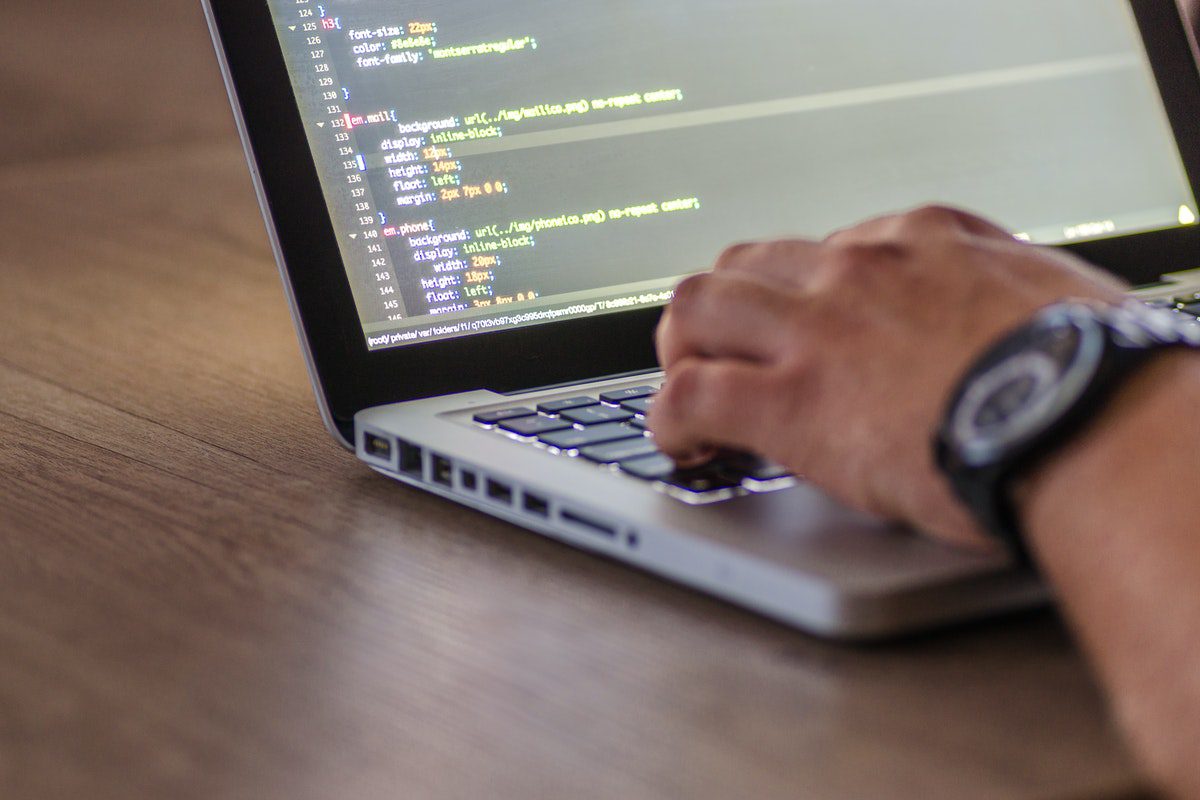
356, 378, 1048, 640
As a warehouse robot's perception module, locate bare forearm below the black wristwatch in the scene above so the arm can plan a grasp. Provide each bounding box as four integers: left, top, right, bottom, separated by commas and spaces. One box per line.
1021, 354, 1200, 798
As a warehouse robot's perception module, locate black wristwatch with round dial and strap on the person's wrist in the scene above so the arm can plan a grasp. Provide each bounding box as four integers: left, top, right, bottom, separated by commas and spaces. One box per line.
935, 300, 1200, 566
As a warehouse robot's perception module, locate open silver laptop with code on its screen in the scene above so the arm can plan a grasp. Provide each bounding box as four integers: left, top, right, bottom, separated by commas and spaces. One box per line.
205, 0, 1200, 639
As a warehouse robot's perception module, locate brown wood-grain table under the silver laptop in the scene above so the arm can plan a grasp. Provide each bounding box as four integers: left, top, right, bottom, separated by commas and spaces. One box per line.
0, 0, 1139, 800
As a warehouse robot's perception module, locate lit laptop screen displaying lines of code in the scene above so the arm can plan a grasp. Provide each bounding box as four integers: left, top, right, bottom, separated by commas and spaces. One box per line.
269, 0, 1198, 350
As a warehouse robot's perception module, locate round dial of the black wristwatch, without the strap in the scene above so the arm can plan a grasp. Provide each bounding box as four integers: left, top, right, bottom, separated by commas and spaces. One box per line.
949, 309, 1104, 467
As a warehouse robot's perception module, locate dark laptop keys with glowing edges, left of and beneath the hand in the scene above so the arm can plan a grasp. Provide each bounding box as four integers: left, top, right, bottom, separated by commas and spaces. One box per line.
474, 384, 796, 505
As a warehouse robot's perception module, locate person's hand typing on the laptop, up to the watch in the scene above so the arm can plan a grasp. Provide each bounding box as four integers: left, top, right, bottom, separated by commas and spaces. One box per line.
649, 207, 1123, 547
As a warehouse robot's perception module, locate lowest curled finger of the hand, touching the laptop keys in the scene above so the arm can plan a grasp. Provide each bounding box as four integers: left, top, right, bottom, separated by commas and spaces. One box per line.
649, 357, 779, 462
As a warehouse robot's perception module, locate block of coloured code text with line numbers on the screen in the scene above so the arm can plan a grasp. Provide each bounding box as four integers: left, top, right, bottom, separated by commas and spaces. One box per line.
282, 0, 701, 323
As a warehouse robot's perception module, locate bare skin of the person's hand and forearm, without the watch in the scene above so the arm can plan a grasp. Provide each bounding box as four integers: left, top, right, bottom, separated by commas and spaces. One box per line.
650, 207, 1200, 798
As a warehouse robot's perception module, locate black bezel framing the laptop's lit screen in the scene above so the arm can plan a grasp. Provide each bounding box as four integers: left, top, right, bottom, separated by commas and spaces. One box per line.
205, 0, 1200, 439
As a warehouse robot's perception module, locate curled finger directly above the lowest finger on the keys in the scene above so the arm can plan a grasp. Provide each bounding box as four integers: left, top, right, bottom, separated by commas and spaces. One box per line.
656, 272, 800, 368
